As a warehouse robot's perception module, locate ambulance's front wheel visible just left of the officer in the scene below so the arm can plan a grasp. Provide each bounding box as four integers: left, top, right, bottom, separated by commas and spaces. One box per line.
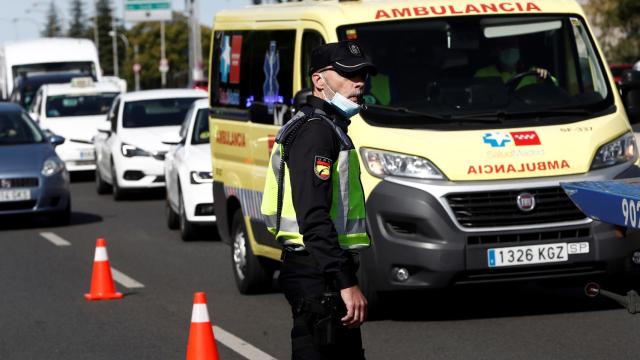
231, 209, 272, 294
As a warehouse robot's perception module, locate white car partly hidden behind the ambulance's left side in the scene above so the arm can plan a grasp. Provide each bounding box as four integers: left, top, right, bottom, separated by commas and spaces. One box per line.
163, 99, 216, 240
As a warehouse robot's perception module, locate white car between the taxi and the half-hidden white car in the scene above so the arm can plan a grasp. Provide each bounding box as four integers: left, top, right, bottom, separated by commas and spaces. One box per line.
94, 89, 207, 200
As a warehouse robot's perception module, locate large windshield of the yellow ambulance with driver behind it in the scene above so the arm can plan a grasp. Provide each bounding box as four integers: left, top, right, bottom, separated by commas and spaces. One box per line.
338, 16, 613, 127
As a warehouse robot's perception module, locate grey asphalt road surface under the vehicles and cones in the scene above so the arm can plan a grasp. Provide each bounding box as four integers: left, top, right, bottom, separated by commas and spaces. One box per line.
0, 178, 640, 359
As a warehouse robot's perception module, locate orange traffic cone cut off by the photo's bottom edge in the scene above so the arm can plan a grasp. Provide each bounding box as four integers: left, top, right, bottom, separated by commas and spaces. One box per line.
187, 292, 219, 360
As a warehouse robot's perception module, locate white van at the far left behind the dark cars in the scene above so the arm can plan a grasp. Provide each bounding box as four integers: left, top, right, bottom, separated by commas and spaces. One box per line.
0, 38, 102, 99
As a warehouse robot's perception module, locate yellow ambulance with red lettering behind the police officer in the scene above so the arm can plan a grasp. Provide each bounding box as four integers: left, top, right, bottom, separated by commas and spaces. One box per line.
209, 0, 640, 303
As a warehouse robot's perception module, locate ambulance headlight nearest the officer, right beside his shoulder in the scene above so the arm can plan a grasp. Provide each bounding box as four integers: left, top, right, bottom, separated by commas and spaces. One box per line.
360, 148, 445, 180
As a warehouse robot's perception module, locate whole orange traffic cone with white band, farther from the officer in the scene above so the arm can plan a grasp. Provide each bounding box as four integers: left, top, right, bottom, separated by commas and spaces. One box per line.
84, 238, 122, 300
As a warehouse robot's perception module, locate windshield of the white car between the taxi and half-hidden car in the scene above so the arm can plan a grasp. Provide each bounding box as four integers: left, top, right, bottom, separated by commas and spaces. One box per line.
122, 98, 199, 128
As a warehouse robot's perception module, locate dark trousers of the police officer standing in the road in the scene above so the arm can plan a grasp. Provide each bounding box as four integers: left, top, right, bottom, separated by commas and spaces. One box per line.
279, 251, 364, 360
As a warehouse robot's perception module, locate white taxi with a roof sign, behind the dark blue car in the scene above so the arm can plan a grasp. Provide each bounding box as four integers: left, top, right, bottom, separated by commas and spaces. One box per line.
29, 78, 120, 172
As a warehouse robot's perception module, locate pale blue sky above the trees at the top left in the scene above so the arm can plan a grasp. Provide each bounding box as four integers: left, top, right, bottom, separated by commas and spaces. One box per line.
0, 0, 251, 44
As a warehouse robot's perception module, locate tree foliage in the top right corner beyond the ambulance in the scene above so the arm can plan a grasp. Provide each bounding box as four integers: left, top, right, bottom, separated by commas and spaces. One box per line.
585, 0, 640, 62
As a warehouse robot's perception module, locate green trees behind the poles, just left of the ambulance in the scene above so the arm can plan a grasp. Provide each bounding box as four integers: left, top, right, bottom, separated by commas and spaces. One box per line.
122, 12, 211, 89
